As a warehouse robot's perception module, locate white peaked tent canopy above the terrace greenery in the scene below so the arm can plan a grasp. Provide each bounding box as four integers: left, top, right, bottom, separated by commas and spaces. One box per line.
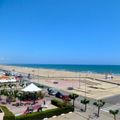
22, 83, 42, 92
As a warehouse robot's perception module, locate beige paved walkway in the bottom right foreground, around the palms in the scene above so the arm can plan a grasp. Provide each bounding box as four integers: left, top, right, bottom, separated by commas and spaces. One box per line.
48, 105, 120, 120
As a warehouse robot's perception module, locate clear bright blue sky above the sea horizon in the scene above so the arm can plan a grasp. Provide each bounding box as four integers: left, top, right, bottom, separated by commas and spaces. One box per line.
0, 0, 120, 64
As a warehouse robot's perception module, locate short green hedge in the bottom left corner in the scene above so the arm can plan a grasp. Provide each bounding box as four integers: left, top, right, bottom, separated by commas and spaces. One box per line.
0, 105, 15, 120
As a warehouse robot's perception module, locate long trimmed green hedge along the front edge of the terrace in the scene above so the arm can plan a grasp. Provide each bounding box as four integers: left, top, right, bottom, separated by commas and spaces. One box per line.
16, 107, 73, 120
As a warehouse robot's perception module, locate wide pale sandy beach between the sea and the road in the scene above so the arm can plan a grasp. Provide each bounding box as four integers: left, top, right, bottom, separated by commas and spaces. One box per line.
0, 65, 120, 99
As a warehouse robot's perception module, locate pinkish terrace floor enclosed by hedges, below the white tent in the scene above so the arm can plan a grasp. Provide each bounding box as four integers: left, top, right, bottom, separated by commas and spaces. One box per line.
0, 97, 56, 116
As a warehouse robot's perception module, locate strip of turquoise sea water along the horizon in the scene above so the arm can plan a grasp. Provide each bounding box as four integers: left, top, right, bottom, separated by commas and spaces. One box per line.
8, 64, 120, 74
